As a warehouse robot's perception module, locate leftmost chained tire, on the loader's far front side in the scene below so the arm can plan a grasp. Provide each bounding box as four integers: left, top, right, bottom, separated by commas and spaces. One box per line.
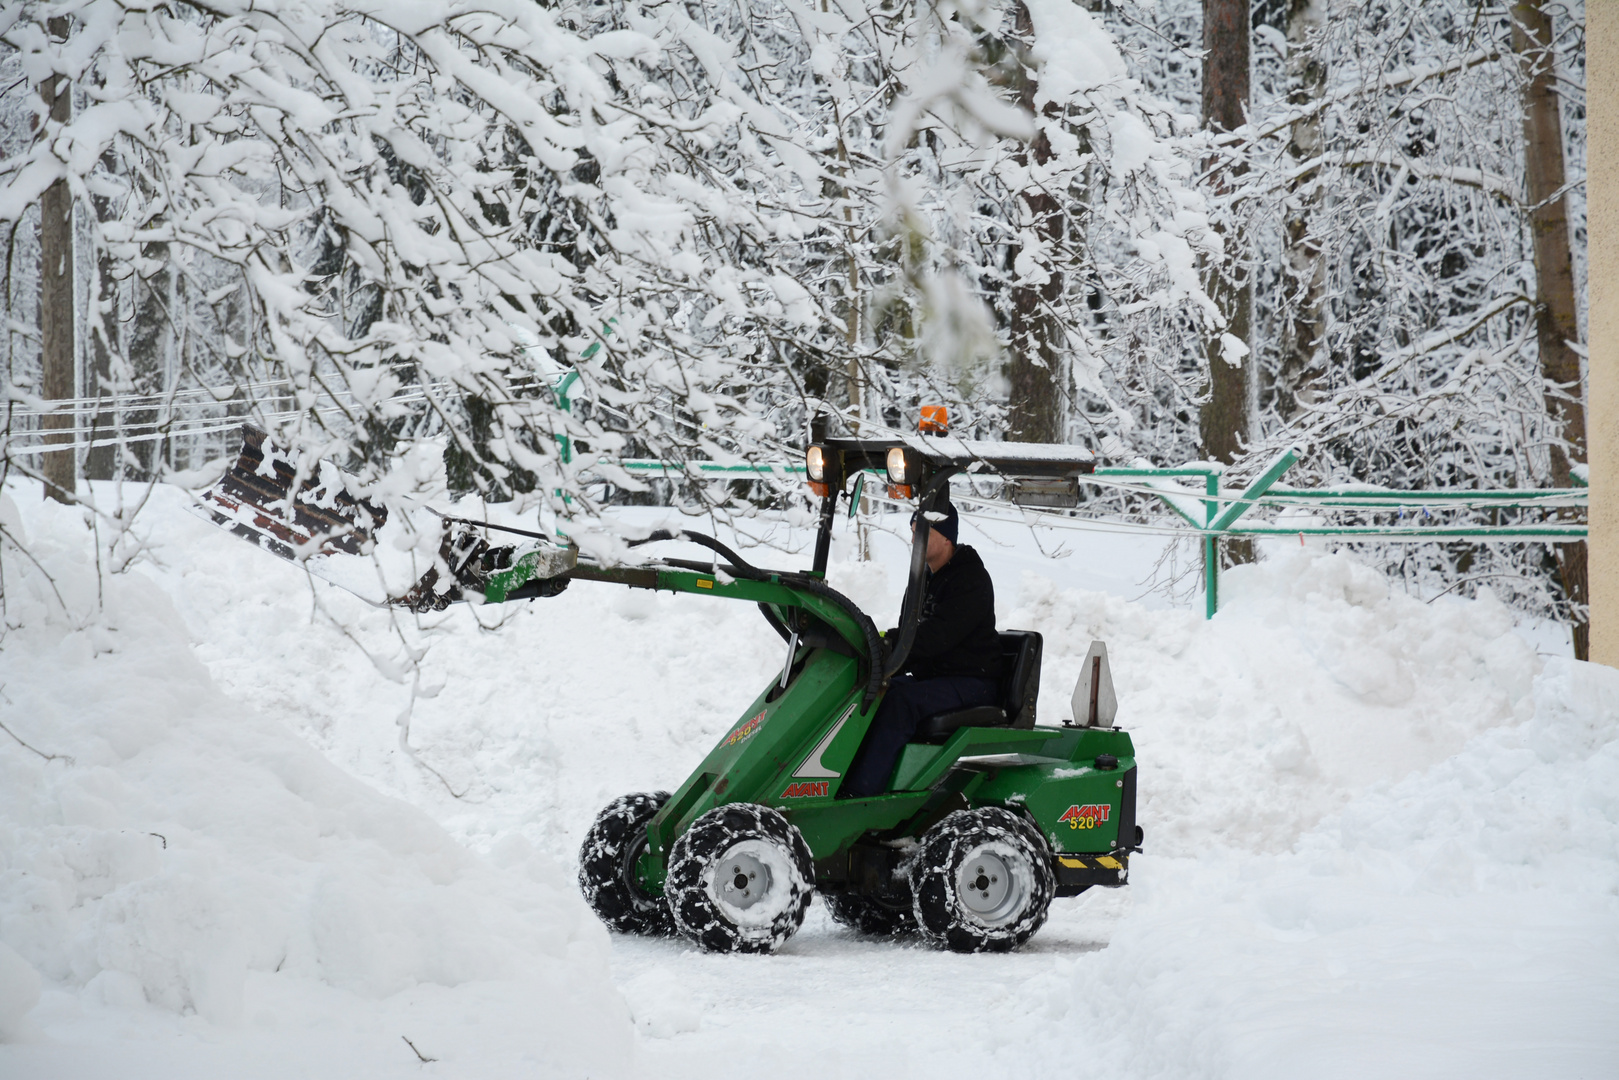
580, 792, 675, 936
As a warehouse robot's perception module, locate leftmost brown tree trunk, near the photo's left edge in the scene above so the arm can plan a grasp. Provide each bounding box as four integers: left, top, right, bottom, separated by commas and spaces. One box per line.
39, 16, 76, 502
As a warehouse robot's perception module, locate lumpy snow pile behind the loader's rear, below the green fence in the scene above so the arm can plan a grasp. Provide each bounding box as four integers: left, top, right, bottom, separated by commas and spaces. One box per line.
1004, 546, 1538, 855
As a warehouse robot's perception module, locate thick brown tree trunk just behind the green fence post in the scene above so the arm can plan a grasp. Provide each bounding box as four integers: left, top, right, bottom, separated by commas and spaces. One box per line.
1198, 0, 1256, 562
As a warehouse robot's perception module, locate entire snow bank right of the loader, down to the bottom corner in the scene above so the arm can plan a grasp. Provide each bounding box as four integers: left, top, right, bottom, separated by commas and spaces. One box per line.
958, 546, 1619, 1080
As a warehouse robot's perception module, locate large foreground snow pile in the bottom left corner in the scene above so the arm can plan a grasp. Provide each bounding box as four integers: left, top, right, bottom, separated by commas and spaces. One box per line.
0, 495, 631, 1075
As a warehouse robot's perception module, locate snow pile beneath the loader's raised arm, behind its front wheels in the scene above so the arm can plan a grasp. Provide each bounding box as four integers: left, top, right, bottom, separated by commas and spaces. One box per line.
119, 489, 815, 866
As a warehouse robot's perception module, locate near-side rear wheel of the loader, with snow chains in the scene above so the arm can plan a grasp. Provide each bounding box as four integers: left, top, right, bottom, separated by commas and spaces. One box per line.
910, 806, 1057, 952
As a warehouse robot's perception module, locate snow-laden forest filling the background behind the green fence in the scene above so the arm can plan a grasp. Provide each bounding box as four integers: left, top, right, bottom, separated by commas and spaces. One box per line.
0, 0, 1585, 657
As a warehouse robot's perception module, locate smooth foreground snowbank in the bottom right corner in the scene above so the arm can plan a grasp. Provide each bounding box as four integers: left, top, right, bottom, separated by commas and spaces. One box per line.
1030, 659, 1619, 1077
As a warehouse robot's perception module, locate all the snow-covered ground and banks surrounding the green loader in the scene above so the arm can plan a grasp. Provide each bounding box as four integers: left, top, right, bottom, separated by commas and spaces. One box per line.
0, 487, 1619, 1080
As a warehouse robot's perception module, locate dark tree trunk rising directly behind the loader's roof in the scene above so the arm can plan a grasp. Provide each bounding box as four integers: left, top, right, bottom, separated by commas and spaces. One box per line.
1007, 0, 1067, 442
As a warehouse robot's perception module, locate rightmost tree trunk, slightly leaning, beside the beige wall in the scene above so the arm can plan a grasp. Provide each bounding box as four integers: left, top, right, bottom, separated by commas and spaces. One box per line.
1512, 0, 1590, 661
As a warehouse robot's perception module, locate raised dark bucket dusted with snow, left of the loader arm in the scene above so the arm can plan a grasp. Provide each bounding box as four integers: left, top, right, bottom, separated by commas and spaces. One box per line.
199, 424, 389, 562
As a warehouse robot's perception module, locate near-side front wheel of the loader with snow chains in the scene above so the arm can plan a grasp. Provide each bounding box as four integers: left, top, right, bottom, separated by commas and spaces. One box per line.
664, 803, 814, 952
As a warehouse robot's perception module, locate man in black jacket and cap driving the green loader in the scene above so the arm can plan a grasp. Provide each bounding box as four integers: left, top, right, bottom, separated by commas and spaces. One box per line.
842, 502, 1001, 798
